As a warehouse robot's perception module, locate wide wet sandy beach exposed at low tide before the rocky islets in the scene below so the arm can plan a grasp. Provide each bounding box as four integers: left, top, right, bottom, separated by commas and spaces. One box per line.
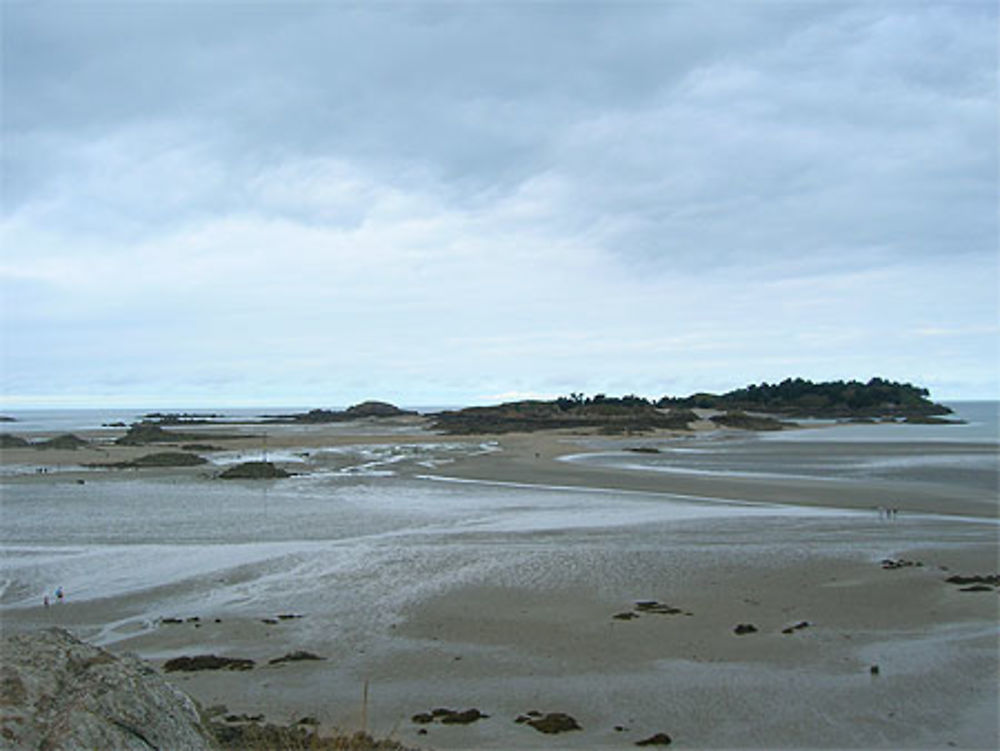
0, 414, 1000, 749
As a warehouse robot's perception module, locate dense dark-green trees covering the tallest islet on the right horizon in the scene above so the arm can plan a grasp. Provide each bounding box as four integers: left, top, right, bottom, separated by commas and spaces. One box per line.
657, 378, 951, 421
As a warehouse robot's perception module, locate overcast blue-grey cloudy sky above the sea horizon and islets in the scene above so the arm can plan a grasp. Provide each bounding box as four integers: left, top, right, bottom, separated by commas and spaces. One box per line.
0, 0, 1000, 408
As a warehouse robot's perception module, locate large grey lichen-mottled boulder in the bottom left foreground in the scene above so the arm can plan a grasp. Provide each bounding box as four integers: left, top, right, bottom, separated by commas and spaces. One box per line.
0, 629, 216, 751
